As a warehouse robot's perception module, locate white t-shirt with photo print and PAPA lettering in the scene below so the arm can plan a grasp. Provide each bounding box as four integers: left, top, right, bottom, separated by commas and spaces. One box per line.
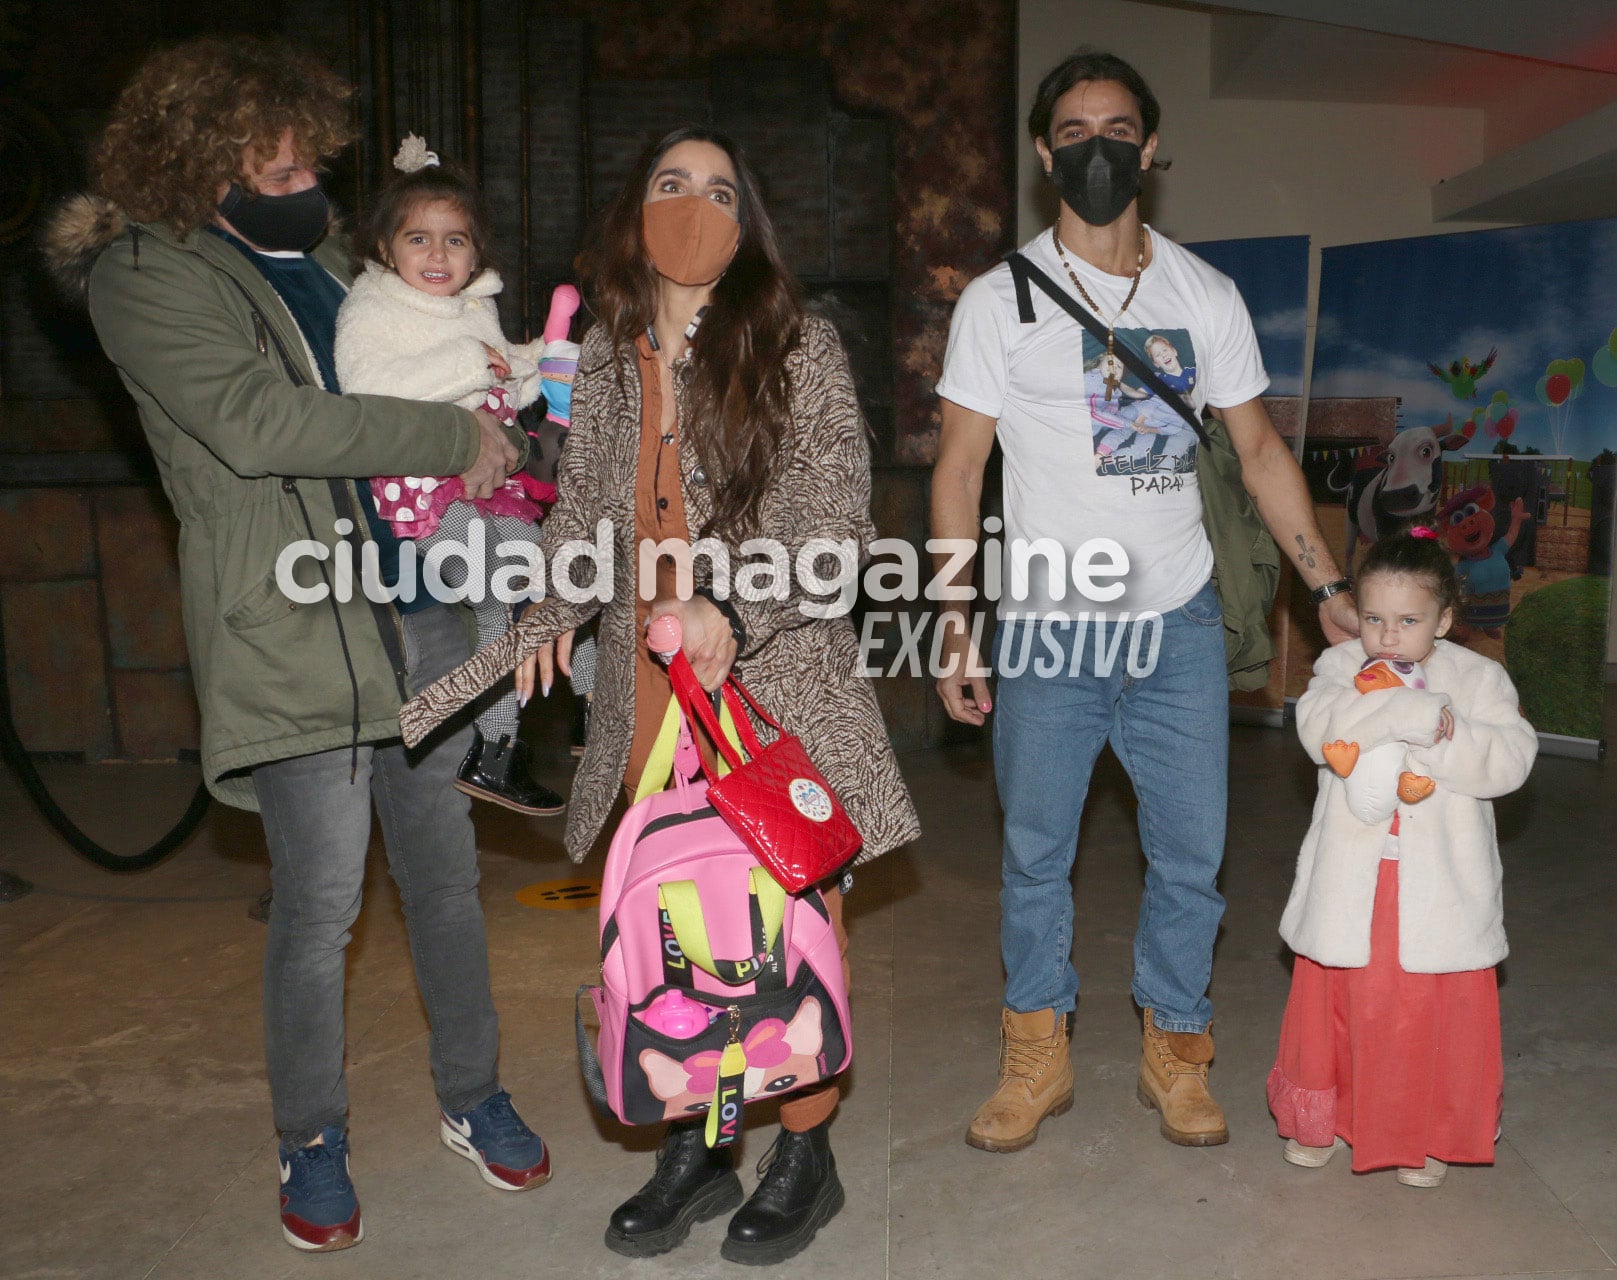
938, 229, 1269, 617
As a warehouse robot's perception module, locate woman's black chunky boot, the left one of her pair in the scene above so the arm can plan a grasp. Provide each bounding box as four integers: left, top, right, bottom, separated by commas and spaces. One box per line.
606, 1118, 741, 1257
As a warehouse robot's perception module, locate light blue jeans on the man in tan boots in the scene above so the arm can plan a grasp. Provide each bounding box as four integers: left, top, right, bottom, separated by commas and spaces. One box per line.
993, 583, 1229, 1031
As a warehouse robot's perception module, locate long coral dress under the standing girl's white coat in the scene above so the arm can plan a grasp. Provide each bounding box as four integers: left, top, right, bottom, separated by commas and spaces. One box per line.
1268, 816, 1504, 1173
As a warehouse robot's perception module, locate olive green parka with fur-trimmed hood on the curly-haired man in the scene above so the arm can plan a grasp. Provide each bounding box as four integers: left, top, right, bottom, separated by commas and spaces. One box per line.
47, 197, 504, 810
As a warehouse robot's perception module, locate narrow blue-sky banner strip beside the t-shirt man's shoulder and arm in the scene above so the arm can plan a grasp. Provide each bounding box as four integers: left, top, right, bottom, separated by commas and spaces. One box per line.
1185, 236, 1308, 724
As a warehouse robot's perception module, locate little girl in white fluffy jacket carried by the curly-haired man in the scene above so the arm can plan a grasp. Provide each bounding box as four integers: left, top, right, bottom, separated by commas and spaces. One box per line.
336, 136, 571, 815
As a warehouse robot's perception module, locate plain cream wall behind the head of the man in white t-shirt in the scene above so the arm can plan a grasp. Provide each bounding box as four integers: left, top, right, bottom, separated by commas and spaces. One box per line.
1017, 0, 1617, 663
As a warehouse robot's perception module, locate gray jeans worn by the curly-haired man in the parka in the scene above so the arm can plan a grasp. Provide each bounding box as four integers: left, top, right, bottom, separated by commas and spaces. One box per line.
252, 604, 500, 1149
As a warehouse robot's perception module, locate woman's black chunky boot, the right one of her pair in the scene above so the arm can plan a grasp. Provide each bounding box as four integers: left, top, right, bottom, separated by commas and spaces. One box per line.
720, 1120, 842, 1267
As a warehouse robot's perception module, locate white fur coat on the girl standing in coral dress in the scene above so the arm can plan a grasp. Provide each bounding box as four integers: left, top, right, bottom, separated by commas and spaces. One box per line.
1281, 640, 1538, 973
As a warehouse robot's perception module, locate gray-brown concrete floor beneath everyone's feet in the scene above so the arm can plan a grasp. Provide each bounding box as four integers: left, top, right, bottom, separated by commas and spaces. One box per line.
0, 711, 1617, 1280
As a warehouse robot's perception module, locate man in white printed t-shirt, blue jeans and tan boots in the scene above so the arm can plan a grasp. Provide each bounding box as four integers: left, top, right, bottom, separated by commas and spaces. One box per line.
931, 52, 1358, 1151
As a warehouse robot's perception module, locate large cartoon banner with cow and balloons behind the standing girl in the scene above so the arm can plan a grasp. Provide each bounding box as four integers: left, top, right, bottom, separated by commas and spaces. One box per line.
1287, 220, 1617, 743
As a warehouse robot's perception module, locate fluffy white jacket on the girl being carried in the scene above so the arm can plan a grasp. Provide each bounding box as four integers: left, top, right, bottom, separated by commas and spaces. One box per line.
336, 262, 545, 409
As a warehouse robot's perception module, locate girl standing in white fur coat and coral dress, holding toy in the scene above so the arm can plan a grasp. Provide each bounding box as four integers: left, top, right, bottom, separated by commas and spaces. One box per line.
1268, 527, 1538, 1186
